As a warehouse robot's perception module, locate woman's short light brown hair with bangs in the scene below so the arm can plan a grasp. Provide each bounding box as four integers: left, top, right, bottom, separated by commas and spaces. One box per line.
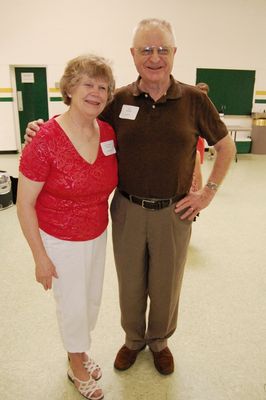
60, 54, 115, 105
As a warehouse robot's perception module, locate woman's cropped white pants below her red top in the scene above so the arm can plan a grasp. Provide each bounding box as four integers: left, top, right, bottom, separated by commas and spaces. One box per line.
40, 231, 107, 353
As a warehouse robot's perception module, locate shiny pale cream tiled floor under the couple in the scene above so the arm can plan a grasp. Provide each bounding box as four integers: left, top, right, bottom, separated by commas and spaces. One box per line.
0, 154, 266, 400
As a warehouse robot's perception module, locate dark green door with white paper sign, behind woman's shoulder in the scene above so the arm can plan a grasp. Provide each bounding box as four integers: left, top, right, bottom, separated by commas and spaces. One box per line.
15, 67, 49, 143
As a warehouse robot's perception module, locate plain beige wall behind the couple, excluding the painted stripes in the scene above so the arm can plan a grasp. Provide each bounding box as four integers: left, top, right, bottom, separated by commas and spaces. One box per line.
0, 0, 266, 151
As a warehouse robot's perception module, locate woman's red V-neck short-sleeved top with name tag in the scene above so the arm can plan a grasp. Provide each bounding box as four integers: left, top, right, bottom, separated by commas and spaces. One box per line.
20, 119, 117, 241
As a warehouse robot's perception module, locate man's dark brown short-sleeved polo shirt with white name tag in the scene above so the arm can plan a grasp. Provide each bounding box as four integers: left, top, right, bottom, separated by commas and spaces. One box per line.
102, 76, 228, 198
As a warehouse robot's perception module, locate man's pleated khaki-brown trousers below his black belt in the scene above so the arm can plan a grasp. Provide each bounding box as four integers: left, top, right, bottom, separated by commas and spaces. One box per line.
111, 190, 191, 351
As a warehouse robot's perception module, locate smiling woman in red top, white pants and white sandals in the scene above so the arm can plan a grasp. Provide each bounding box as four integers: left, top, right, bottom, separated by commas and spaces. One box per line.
17, 55, 117, 400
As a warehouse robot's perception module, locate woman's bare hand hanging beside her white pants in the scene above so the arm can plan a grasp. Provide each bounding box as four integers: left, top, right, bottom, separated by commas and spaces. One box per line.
35, 255, 58, 290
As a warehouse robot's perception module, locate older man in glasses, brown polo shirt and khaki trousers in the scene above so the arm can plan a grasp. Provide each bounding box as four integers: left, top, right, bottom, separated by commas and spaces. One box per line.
23, 19, 235, 375
